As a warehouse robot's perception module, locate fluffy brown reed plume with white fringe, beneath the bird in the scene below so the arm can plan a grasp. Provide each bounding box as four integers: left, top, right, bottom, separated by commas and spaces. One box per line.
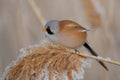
2, 40, 89, 80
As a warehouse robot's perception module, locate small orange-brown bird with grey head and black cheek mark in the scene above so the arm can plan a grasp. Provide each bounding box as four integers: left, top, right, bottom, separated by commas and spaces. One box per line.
42, 20, 108, 71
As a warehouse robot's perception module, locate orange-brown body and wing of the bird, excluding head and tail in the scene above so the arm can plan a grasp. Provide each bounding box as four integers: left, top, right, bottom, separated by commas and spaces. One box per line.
58, 20, 87, 48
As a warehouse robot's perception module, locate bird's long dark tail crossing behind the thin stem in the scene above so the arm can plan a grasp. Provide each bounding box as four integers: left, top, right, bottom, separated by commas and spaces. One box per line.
84, 43, 108, 71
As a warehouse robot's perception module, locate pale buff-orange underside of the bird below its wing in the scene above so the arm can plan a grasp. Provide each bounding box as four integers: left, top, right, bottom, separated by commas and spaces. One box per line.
57, 32, 86, 48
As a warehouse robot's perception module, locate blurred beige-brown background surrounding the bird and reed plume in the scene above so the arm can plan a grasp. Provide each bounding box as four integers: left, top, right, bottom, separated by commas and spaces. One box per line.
0, 0, 120, 80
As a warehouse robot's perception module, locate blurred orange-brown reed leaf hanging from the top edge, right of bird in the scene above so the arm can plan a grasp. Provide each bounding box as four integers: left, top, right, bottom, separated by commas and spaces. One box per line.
81, 0, 102, 27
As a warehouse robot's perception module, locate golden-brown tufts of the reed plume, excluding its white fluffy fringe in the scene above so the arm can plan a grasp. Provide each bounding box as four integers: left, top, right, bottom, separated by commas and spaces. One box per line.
7, 42, 85, 80
